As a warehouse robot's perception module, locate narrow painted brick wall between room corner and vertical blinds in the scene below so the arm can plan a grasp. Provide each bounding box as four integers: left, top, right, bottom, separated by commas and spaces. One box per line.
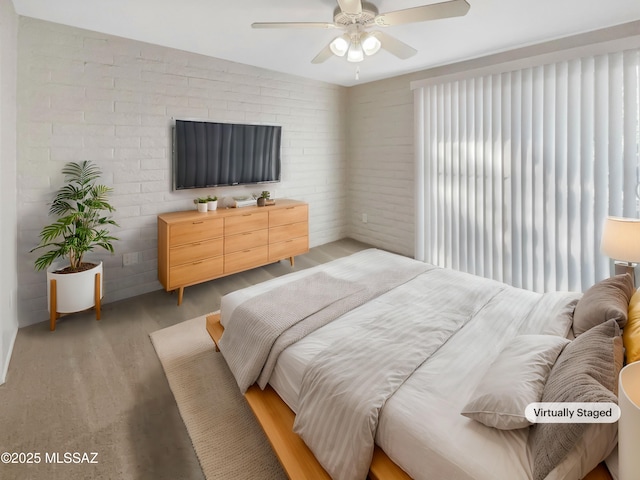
347, 74, 420, 256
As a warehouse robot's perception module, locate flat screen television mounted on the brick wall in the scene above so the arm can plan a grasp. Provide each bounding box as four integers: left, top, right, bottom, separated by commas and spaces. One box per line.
173, 120, 282, 190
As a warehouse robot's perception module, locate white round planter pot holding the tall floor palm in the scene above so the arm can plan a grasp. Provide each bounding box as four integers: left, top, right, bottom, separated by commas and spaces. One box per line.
47, 262, 104, 313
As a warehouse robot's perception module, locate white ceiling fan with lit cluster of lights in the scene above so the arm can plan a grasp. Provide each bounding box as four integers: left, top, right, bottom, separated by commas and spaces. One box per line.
251, 0, 470, 63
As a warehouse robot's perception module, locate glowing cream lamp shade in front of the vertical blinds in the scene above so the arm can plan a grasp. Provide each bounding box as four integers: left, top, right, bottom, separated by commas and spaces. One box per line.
600, 217, 640, 263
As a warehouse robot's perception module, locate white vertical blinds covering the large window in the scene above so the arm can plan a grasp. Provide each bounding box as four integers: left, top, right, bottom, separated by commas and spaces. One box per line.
414, 50, 640, 292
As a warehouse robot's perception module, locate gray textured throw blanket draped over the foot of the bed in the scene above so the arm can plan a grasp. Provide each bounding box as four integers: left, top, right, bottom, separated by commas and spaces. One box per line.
219, 263, 433, 393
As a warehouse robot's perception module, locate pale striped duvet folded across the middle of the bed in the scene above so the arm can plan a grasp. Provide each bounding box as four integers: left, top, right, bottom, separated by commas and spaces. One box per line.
294, 269, 505, 480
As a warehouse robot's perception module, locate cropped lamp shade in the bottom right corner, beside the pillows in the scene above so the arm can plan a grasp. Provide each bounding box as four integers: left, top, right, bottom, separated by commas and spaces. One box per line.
618, 362, 640, 480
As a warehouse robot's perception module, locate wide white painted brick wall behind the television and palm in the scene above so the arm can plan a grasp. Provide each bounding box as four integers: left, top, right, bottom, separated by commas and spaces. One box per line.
17, 17, 347, 326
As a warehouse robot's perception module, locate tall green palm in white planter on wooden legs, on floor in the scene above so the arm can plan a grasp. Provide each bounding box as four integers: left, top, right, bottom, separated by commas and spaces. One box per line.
31, 160, 118, 331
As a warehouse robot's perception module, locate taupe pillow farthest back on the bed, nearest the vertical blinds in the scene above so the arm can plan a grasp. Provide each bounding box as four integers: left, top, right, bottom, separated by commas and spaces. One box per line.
573, 274, 634, 337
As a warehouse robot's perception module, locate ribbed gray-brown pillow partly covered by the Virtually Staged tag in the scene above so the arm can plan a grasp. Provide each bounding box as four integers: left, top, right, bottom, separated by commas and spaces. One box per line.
528, 319, 623, 480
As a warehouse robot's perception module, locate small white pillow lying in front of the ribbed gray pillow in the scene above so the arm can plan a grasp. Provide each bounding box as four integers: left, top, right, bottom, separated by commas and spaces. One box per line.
461, 335, 569, 430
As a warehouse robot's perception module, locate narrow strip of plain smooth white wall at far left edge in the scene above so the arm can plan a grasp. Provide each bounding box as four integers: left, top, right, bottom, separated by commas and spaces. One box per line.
0, 0, 18, 384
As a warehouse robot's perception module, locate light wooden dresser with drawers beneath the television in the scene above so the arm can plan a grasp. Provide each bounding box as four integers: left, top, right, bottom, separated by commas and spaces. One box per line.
158, 200, 309, 305
